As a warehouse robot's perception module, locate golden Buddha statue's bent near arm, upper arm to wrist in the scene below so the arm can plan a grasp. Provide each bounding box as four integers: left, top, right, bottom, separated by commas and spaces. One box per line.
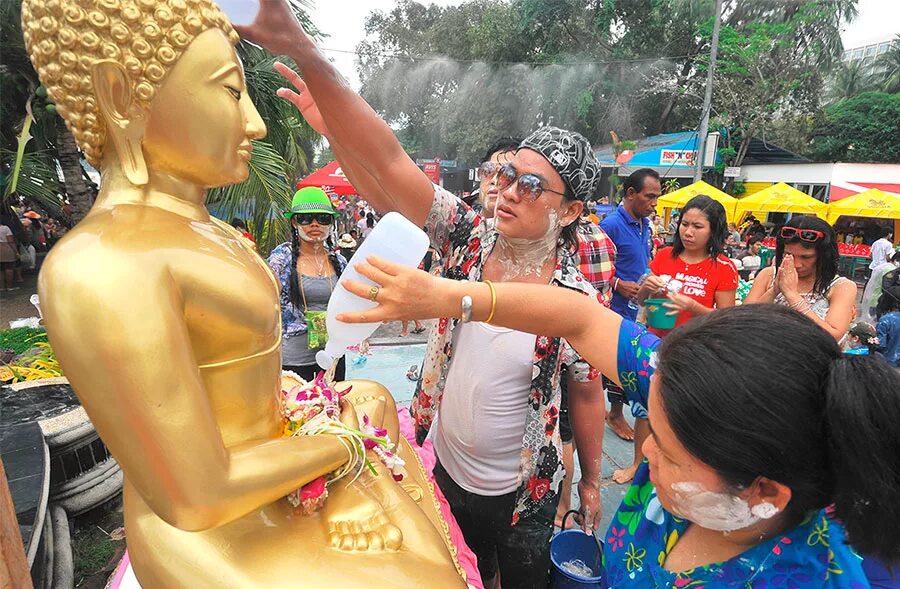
40, 258, 348, 531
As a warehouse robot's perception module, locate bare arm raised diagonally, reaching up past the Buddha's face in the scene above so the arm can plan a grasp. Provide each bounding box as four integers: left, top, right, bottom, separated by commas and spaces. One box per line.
236, 0, 434, 227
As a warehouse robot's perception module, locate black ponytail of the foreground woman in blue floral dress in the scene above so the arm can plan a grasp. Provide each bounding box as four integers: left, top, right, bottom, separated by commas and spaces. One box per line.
825, 356, 900, 564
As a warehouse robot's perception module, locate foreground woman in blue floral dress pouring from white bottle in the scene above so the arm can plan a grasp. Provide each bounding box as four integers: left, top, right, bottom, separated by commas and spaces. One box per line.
340, 259, 900, 588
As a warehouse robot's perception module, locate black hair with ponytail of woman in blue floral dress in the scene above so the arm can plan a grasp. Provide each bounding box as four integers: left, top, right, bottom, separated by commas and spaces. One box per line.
656, 305, 900, 563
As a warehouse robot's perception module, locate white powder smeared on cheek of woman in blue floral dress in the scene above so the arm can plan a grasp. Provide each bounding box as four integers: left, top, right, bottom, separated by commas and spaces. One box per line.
672, 482, 774, 532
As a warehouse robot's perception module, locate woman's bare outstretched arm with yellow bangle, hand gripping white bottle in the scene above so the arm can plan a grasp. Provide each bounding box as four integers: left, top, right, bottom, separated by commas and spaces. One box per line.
338, 256, 622, 383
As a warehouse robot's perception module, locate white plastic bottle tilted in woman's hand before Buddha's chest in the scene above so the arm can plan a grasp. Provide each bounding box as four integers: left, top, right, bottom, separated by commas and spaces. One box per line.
316, 213, 429, 370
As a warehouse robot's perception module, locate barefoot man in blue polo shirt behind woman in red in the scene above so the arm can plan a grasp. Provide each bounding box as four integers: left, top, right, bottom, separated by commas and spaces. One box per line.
600, 168, 662, 484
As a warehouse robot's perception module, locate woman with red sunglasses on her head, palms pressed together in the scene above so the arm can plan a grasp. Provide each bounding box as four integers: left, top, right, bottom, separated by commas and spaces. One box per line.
744, 216, 856, 341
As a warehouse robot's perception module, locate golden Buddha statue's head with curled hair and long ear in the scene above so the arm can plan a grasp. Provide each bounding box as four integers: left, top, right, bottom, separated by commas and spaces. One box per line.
22, 0, 265, 187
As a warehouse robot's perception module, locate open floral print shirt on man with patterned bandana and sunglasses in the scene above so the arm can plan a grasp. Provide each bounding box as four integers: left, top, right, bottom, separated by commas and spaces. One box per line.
410, 186, 600, 525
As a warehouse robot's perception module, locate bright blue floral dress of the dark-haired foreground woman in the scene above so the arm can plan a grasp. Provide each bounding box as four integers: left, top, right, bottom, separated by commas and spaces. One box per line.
603, 321, 869, 589
